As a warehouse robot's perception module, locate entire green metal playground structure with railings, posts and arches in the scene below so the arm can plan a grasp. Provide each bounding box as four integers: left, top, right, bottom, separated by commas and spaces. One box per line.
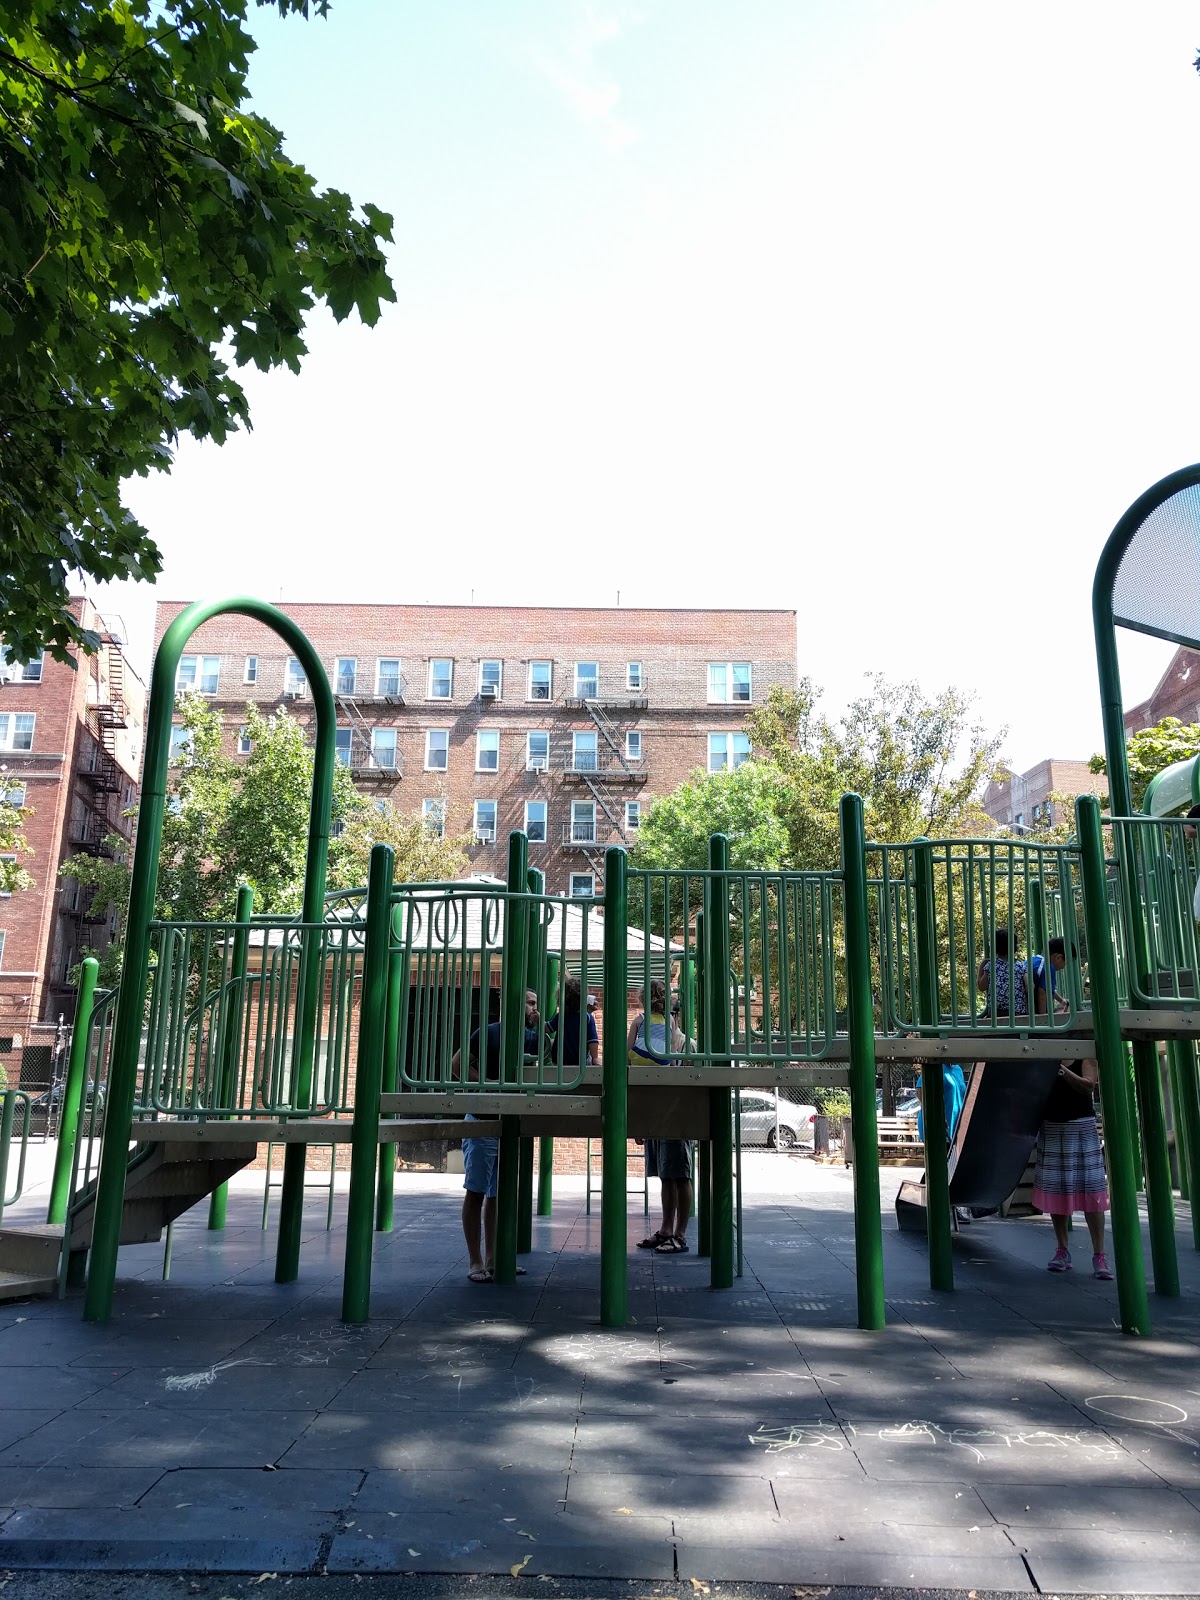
0, 467, 1200, 1334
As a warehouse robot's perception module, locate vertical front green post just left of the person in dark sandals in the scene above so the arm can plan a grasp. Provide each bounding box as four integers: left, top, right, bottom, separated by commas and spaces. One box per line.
600, 845, 629, 1328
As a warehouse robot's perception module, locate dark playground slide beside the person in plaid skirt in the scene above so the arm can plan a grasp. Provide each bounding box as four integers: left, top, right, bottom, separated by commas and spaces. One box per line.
896, 1061, 1059, 1234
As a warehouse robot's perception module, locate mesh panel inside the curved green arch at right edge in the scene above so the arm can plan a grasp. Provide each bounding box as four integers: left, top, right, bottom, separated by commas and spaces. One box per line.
1112, 485, 1200, 645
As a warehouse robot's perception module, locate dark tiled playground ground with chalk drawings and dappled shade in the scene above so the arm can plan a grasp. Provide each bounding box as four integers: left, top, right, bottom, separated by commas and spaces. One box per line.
0, 1154, 1200, 1595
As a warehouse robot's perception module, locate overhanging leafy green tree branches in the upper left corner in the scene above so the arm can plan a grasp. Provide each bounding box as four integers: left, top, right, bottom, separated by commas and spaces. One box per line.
0, 0, 395, 661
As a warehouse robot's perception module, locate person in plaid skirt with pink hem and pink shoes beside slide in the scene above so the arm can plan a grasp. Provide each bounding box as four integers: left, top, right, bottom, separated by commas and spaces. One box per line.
1034, 1061, 1112, 1278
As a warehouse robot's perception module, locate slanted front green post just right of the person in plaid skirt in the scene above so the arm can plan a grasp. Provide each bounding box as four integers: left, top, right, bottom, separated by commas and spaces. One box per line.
1075, 795, 1150, 1334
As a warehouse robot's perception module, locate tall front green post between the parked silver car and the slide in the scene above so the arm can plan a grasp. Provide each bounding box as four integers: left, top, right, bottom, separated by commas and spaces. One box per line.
840, 795, 886, 1328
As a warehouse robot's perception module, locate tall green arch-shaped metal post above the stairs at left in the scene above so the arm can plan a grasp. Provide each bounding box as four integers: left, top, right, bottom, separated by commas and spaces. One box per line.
83, 598, 336, 1322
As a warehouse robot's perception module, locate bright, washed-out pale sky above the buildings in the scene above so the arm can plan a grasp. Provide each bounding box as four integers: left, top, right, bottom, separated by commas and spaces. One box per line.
101, 0, 1200, 768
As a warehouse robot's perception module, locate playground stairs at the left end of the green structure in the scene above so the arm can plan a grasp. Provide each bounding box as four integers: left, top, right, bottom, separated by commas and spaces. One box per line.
0, 1139, 258, 1301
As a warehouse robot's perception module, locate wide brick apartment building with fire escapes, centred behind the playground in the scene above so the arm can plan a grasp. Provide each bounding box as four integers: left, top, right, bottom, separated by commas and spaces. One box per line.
155, 602, 797, 894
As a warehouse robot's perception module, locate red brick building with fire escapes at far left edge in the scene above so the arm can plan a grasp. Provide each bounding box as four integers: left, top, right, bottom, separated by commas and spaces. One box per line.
0, 598, 146, 1085
